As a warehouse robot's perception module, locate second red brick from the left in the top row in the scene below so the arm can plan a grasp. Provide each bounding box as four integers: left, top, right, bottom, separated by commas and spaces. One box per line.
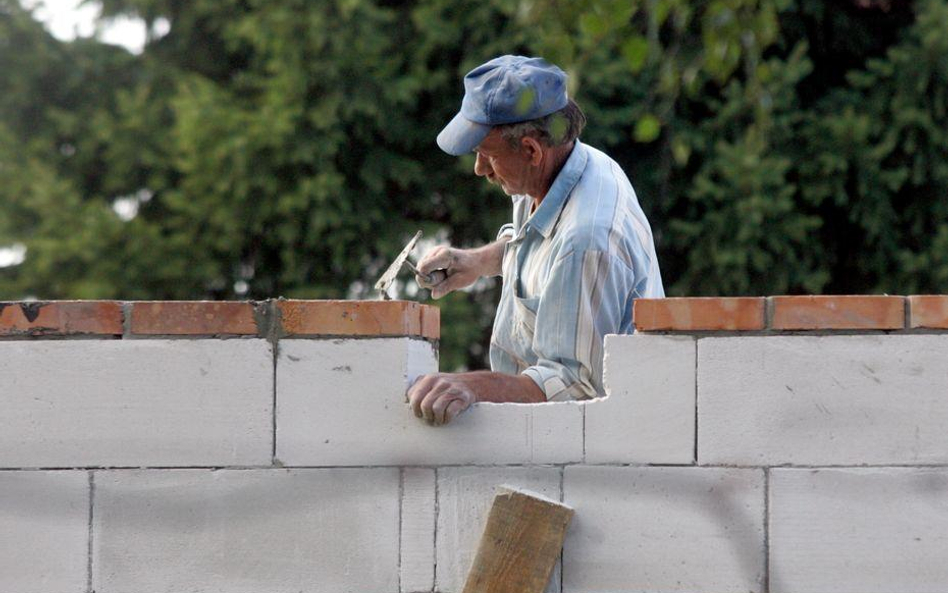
131, 301, 257, 335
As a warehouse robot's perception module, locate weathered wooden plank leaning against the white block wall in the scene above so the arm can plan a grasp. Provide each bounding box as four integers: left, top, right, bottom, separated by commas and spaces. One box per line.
464, 486, 573, 593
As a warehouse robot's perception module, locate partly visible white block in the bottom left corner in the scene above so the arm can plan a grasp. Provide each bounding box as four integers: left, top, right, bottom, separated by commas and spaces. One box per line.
0, 471, 90, 593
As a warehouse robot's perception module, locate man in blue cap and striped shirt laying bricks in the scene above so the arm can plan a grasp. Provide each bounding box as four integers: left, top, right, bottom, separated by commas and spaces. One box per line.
407, 56, 664, 424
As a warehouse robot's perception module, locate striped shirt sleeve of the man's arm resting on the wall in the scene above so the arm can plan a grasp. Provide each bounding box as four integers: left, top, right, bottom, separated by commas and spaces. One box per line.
518, 250, 635, 401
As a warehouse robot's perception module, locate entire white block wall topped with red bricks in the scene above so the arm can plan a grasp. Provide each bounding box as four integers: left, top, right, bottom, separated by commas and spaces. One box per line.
0, 296, 948, 593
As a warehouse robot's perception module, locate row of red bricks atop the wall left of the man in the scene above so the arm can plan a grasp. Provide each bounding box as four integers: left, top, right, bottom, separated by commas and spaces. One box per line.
0, 299, 441, 340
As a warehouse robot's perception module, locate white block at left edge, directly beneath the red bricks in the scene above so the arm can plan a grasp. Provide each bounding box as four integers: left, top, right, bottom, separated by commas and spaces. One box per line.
0, 340, 273, 467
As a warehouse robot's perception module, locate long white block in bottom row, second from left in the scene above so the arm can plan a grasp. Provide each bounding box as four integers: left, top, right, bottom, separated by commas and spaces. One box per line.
92, 468, 399, 593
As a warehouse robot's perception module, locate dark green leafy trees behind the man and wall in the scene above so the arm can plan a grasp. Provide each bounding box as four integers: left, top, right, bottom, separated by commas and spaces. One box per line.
0, 0, 948, 370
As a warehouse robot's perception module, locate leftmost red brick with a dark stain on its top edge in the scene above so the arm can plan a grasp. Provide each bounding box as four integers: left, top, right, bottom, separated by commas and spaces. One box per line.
0, 301, 122, 335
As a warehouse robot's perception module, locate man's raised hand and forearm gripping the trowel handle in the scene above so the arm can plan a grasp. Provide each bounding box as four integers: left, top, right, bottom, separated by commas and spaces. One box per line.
415, 239, 507, 299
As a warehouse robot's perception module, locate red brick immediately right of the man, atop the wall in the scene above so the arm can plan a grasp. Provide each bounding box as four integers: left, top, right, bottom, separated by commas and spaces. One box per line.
633, 297, 764, 332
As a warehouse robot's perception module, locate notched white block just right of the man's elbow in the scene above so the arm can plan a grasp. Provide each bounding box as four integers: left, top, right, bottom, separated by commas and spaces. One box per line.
586, 334, 695, 464
